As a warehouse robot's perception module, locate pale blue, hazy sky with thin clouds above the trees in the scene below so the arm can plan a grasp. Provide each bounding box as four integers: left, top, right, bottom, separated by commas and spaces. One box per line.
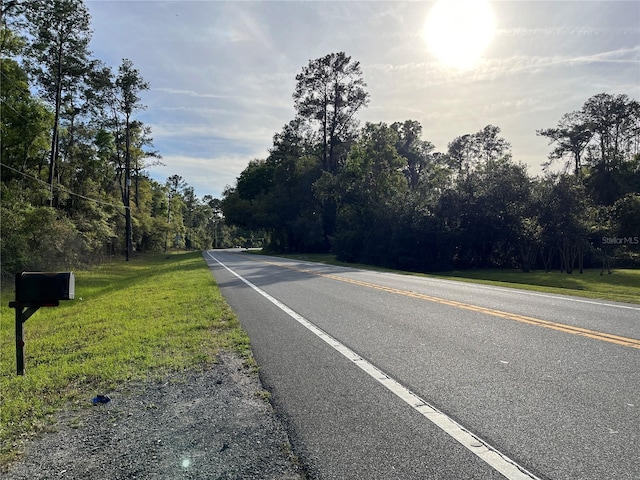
85, 0, 640, 198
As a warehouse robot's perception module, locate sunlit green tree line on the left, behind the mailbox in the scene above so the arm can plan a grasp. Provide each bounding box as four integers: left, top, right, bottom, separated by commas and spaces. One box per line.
0, 0, 252, 276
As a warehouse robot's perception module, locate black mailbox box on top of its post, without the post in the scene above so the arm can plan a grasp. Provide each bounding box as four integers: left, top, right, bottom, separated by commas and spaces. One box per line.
16, 272, 76, 306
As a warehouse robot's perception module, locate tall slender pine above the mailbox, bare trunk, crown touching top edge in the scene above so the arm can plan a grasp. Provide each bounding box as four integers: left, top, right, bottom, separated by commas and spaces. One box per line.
25, 0, 91, 205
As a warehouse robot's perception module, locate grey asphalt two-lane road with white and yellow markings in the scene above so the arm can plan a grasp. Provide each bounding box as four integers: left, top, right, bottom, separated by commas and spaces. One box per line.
204, 251, 640, 480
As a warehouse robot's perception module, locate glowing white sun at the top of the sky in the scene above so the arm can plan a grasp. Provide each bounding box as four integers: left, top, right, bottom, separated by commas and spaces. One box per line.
423, 0, 496, 70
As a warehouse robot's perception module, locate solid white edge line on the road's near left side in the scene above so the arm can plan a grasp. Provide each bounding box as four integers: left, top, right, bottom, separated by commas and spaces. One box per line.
207, 252, 541, 480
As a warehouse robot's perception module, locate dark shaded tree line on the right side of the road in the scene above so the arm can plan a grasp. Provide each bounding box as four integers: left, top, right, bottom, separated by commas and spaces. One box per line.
222, 52, 640, 273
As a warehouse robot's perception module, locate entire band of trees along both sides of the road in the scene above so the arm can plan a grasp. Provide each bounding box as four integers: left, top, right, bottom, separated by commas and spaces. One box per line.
0, 0, 640, 276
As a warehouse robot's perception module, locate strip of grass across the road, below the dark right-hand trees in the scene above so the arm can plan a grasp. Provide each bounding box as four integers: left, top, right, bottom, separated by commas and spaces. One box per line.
253, 252, 640, 304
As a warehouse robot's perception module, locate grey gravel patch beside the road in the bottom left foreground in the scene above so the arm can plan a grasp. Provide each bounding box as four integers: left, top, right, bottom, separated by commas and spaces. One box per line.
2, 353, 306, 480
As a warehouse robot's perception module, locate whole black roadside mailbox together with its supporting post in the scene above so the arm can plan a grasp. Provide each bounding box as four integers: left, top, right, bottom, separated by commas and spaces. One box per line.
9, 272, 75, 375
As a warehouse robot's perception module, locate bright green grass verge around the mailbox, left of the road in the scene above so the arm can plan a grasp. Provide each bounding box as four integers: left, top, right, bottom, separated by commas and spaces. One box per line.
0, 252, 250, 467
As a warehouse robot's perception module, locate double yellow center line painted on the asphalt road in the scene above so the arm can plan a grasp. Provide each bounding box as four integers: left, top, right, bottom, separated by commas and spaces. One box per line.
265, 262, 640, 348
